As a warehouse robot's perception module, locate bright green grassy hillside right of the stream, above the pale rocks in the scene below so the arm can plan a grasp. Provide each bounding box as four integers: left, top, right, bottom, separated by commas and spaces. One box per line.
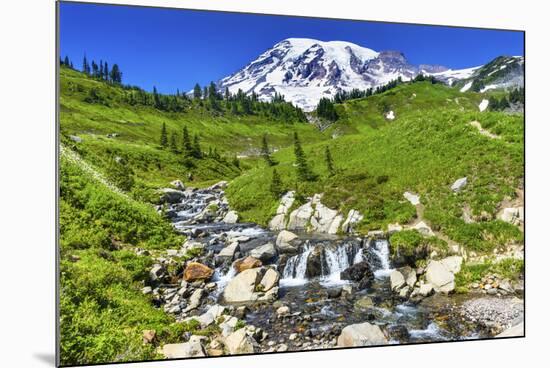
228, 82, 523, 250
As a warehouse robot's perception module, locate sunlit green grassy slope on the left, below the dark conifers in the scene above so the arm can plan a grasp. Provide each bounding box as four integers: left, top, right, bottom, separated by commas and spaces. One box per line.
60, 67, 325, 187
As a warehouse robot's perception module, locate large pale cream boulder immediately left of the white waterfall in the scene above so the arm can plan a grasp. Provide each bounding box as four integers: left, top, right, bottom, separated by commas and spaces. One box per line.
223, 268, 280, 304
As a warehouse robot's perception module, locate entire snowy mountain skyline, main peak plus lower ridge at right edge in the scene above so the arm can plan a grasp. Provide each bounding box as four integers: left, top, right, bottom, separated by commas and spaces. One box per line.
218, 38, 523, 111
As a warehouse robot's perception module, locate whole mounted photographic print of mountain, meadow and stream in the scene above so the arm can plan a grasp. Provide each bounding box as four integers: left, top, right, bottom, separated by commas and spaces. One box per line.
57, 2, 525, 366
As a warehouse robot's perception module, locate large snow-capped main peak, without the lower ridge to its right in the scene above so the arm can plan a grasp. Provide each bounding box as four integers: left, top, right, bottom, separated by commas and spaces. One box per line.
218, 38, 447, 111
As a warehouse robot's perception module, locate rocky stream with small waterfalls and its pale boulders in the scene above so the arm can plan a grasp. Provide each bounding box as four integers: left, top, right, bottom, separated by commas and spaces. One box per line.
143, 182, 523, 358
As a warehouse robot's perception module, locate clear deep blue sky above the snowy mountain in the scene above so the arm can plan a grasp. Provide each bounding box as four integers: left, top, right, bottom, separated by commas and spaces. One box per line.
60, 2, 523, 93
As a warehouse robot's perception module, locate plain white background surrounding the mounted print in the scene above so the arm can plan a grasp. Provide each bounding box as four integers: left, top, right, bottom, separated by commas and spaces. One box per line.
0, 0, 550, 368
